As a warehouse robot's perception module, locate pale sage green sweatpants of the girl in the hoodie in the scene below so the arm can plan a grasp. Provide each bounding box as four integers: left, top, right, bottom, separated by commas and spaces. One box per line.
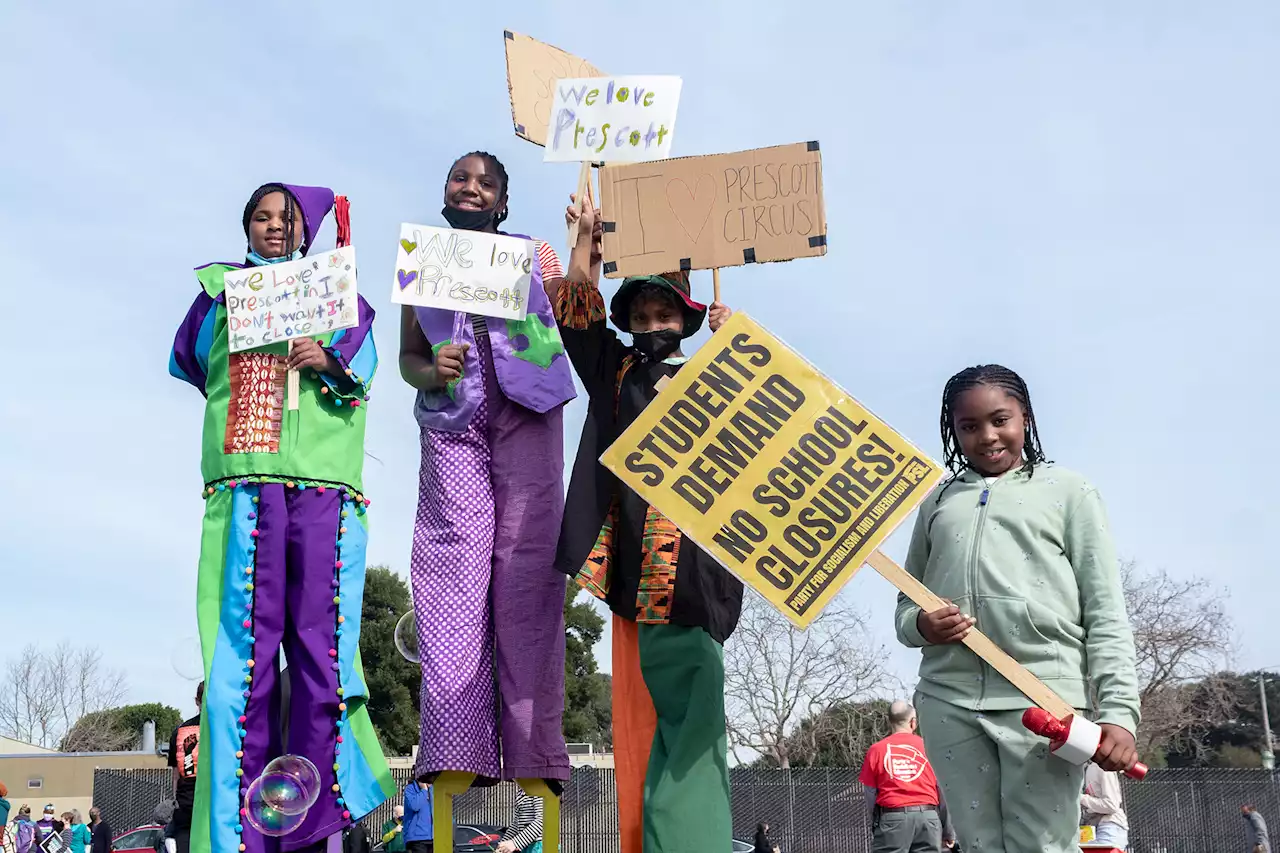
915, 694, 1084, 853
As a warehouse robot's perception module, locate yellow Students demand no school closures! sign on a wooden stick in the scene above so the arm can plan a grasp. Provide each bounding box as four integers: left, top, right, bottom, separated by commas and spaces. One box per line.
600, 314, 942, 628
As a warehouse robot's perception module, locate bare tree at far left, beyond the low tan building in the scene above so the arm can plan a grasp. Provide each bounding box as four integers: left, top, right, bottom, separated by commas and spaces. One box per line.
0, 643, 128, 748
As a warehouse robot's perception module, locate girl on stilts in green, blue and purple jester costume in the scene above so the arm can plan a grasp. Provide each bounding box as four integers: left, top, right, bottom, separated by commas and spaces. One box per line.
169, 183, 394, 853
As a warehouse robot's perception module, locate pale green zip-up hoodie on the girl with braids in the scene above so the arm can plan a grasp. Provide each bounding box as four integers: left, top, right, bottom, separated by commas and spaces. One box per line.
897, 465, 1139, 733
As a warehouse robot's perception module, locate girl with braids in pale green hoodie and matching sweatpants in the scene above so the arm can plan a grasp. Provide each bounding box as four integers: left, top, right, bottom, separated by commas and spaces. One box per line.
897, 365, 1138, 853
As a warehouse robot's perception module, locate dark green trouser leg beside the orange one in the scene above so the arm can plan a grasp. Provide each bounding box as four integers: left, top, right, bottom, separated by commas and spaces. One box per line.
639, 625, 733, 853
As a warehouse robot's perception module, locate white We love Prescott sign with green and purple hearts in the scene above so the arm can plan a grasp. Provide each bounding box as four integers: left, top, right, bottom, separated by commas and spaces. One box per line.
392, 223, 538, 320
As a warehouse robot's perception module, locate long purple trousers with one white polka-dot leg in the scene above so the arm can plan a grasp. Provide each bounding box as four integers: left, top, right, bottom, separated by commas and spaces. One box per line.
411, 337, 570, 784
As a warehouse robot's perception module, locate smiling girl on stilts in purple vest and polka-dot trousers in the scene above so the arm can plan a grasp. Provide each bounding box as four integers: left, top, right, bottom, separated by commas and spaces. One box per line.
399, 152, 575, 788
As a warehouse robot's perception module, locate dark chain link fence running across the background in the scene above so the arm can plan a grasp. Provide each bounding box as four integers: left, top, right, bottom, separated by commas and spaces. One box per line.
93, 767, 1280, 853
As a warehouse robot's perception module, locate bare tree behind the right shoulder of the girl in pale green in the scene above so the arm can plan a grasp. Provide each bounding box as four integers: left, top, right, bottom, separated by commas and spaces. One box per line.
1120, 560, 1233, 754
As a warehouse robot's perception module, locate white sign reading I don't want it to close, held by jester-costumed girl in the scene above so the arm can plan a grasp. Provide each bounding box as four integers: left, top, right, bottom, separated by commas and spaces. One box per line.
223, 246, 360, 352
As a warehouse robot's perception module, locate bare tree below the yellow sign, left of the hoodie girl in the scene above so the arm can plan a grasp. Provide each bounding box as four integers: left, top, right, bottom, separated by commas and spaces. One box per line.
724, 593, 895, 767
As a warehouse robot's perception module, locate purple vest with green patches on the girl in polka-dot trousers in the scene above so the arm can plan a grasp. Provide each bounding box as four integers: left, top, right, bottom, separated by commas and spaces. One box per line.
413, 234, 577, 433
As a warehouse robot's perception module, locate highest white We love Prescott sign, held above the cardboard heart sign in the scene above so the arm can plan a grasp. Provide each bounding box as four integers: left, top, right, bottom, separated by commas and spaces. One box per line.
543, 76, 681, 163
